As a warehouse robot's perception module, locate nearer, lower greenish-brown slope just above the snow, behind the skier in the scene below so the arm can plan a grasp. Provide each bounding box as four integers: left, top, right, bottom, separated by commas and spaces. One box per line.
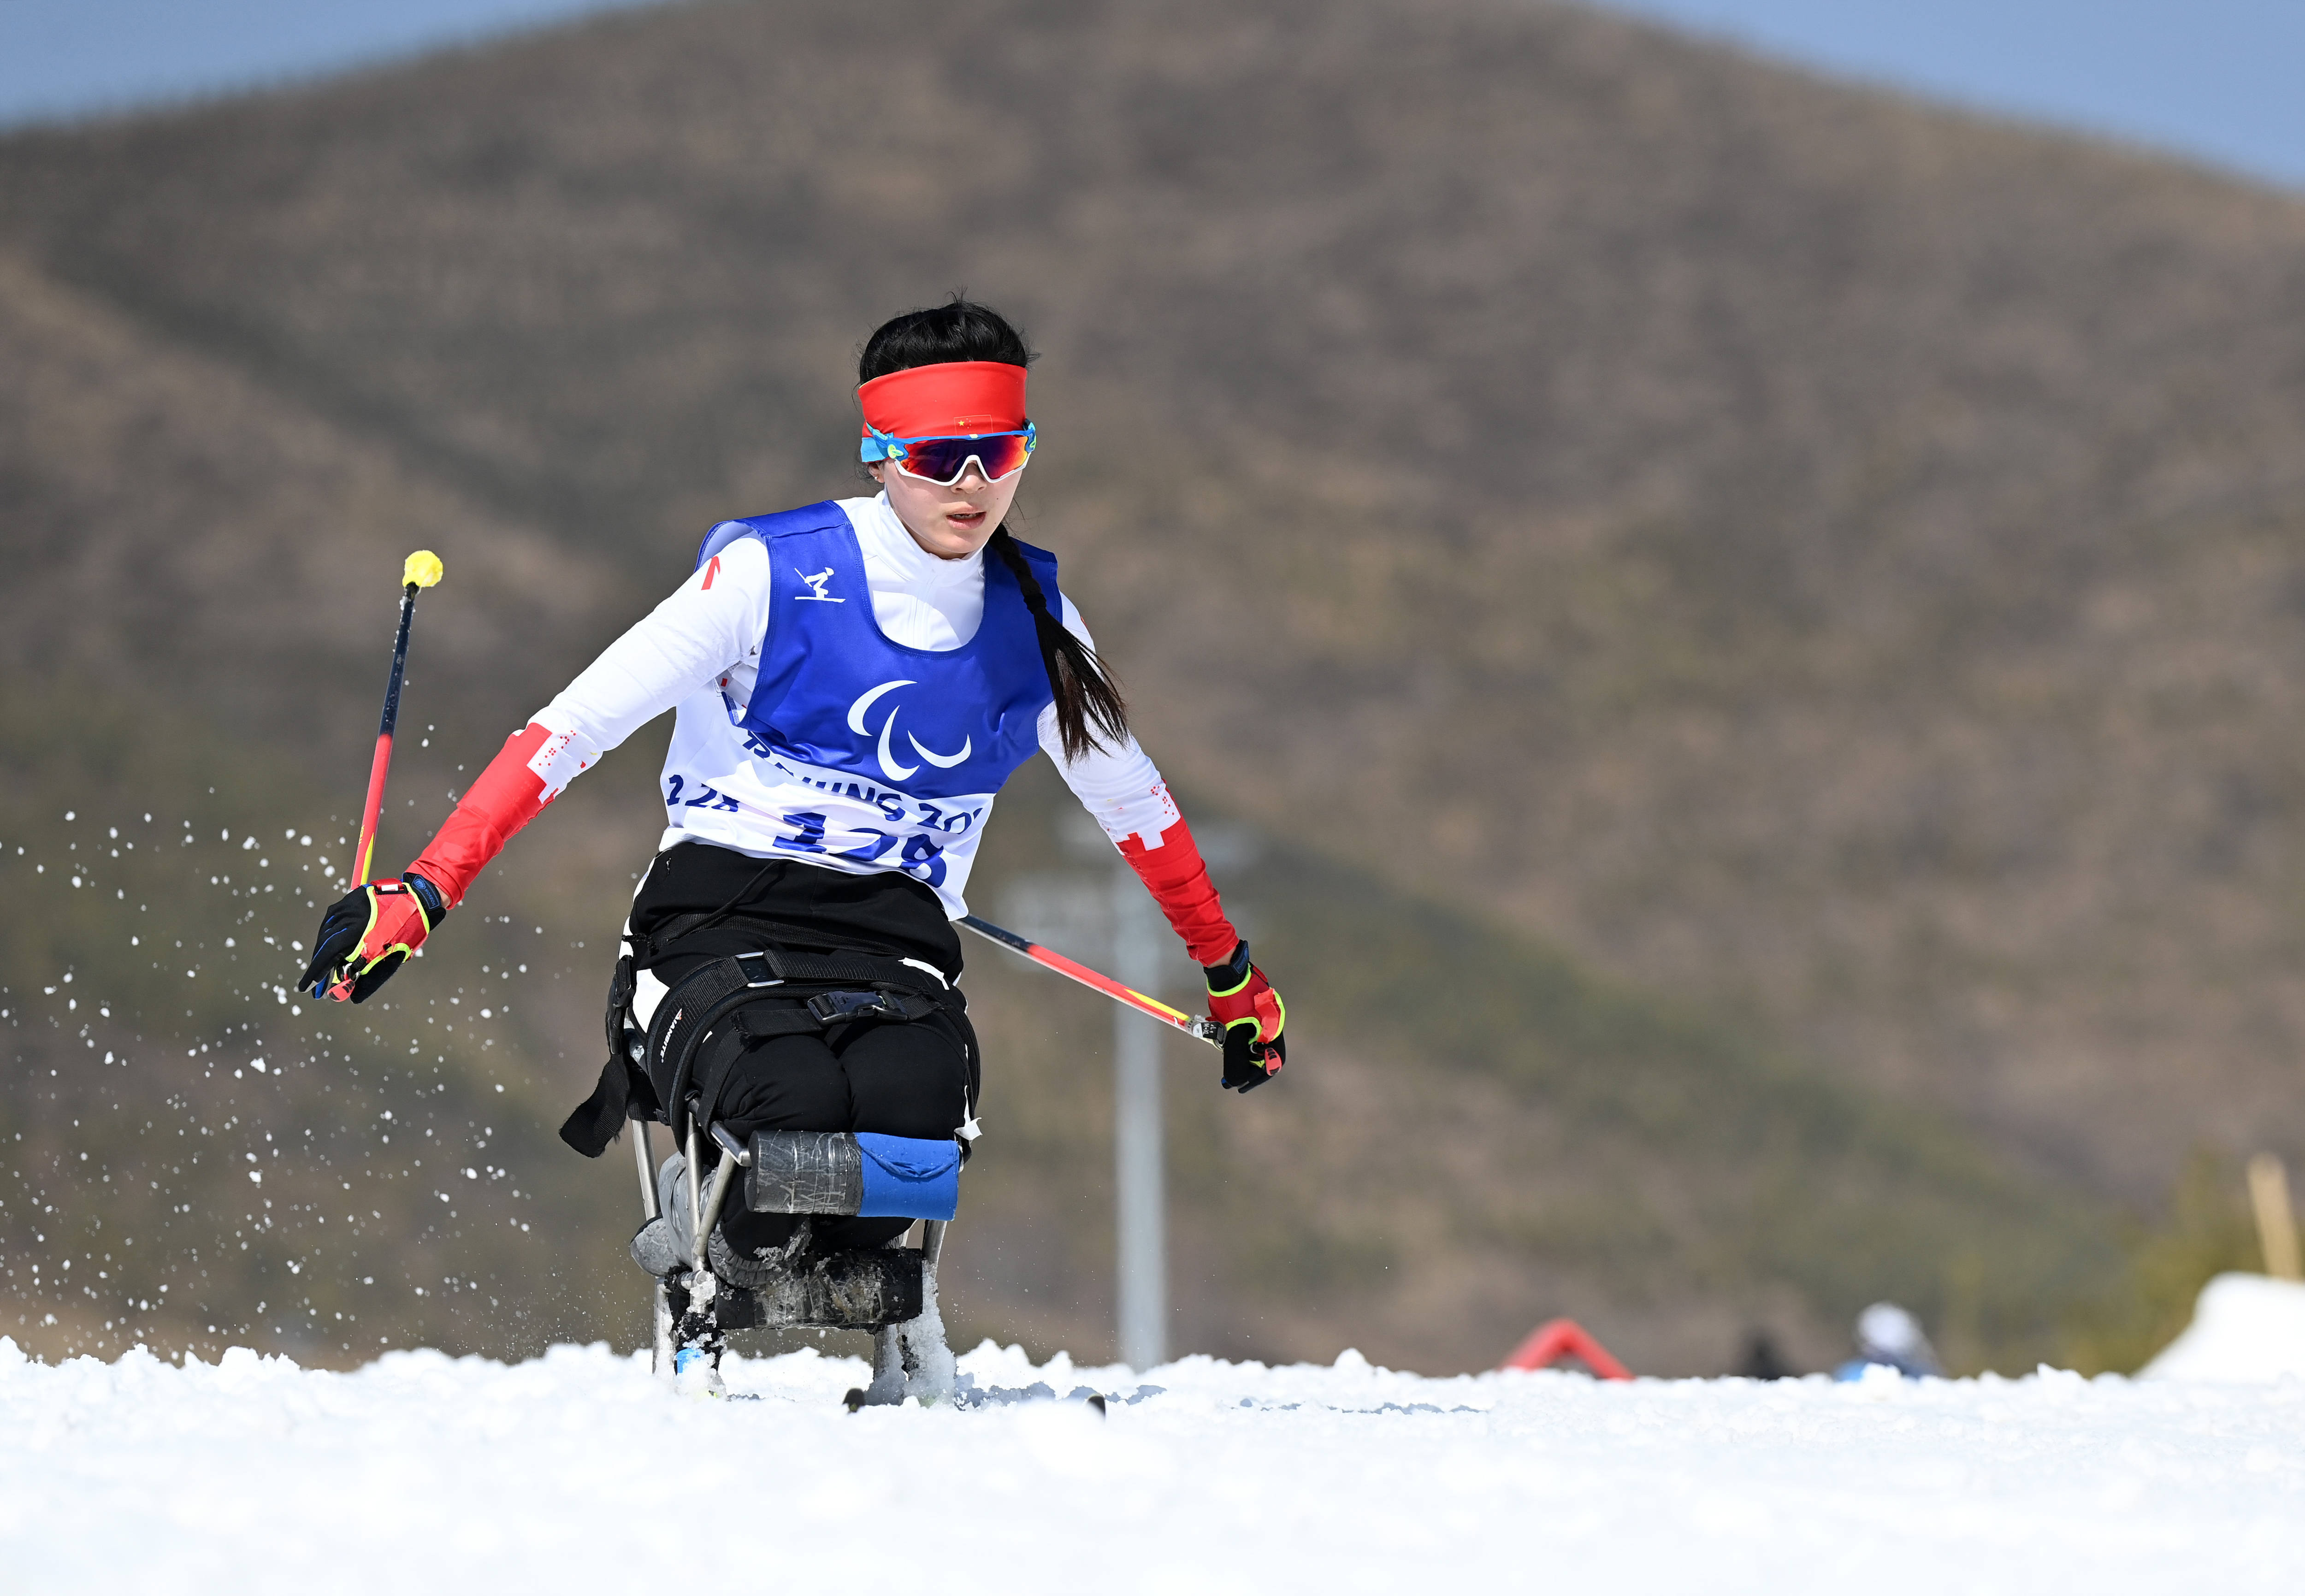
0, 234, 2107, 1370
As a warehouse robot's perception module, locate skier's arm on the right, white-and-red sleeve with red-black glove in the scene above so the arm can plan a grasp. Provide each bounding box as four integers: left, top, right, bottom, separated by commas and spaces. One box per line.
1040, 597, 1286, 1091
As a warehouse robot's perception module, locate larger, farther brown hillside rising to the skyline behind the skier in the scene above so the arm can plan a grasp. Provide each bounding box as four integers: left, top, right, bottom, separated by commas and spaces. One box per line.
0, 0, 2305, 1190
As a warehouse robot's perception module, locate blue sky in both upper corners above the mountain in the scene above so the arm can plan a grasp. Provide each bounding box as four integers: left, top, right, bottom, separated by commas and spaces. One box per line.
0, 0, 2305, 189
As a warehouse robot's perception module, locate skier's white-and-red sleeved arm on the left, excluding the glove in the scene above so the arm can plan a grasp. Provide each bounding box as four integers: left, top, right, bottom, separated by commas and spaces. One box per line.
408, 538, 774, 909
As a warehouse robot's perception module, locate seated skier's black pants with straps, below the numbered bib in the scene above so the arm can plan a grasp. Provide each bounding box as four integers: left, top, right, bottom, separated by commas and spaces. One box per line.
632, 842, 980, 1253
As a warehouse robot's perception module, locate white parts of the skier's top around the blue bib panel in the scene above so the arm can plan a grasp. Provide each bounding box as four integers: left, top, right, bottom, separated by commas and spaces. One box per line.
514, 496, 1178, 918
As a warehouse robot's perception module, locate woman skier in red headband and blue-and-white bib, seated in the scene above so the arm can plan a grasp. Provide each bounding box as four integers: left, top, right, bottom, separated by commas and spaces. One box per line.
304, 297, 1284, 1319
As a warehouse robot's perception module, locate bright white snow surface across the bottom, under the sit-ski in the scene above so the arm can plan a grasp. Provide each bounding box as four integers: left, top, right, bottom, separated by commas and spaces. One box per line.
0, 1340, 2305, 1596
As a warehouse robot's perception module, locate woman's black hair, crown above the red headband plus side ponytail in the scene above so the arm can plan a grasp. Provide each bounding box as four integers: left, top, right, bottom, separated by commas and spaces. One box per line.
857, 295, 1129, 759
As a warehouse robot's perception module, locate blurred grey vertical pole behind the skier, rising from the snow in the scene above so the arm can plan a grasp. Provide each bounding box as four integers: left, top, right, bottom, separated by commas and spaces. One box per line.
1113, 865, 1169, 1370
